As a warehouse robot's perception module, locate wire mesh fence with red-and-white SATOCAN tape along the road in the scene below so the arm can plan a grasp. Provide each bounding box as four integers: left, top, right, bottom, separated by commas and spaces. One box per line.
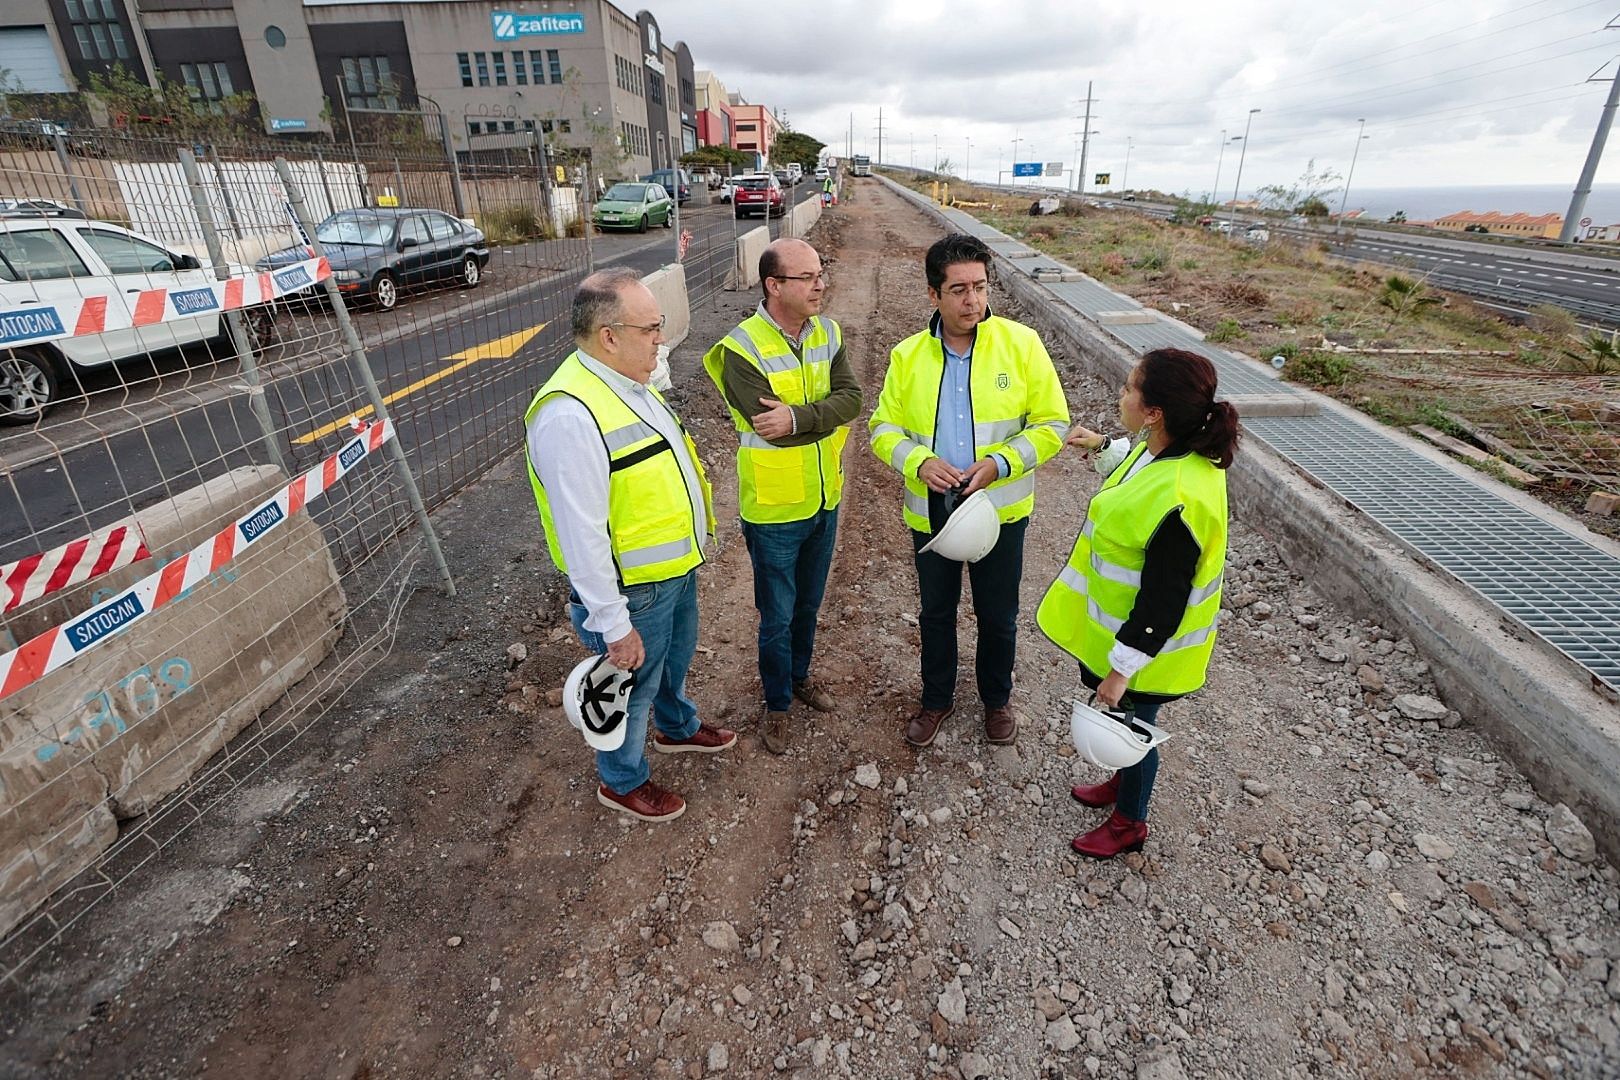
0, 118, 816, 983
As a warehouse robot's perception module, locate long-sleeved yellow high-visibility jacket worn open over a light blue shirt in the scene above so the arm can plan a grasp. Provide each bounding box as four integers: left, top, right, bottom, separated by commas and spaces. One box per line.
870, 316, 1069, 533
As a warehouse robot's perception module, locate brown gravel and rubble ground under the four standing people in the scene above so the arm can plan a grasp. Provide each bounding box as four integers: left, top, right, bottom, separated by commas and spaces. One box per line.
0, 181, 1620, 1080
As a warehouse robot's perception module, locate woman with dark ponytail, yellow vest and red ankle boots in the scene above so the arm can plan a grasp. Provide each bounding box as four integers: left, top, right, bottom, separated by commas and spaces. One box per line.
1035, 348, 1241, 858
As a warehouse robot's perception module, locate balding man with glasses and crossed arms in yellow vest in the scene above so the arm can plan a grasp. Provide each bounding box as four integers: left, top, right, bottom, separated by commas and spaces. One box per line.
703, 240, 860, 755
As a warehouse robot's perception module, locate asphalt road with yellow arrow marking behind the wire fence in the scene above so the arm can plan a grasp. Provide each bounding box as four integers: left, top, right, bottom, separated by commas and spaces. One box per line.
0, 183, 818, 573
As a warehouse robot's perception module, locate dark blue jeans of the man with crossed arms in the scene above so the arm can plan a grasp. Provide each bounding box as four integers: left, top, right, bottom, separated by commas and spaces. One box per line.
742, 510, 838, 712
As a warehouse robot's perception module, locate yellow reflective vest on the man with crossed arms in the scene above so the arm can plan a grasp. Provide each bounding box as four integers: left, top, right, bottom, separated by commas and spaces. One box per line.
703, 313, 849, 525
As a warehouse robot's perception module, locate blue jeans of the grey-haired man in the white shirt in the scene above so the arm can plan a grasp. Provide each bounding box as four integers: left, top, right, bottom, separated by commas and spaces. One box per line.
569, 570, 698, 795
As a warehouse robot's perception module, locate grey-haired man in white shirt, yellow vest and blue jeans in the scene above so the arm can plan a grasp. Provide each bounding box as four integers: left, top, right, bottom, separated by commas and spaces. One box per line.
523, 269, 737, 821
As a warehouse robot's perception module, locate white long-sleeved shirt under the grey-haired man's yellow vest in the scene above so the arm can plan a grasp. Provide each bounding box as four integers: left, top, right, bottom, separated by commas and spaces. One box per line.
528, 350, 711, 641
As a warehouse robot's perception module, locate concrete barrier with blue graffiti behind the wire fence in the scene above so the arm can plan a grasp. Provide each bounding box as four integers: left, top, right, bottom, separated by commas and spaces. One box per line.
0, 466, 347, 933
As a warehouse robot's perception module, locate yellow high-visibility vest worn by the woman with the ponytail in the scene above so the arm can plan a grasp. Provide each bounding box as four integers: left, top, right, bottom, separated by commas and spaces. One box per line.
1035, 444, 1226, 695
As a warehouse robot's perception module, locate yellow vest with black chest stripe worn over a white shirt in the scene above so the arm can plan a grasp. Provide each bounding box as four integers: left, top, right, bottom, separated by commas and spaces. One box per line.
523, 353, 714, 585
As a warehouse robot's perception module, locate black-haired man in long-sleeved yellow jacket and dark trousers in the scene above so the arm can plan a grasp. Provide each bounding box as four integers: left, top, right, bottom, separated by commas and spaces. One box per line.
870, 233, 1069, 748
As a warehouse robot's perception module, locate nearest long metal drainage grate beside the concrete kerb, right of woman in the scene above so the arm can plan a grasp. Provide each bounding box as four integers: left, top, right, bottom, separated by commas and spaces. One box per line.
1244, 413, 1620, 690
